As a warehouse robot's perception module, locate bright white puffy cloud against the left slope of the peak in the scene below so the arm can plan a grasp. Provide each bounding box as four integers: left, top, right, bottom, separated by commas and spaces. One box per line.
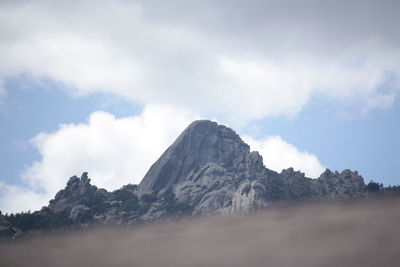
0, 106, 199, 215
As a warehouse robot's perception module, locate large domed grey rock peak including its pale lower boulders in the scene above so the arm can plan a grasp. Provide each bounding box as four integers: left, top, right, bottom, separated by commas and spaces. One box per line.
138, 120, 271, 214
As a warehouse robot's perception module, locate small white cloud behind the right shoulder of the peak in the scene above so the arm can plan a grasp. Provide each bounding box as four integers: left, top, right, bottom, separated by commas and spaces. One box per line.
243, 136, 325, 178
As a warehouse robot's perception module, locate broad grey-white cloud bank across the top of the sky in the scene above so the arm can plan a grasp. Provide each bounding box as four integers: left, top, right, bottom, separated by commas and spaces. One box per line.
0, 0, 400, 123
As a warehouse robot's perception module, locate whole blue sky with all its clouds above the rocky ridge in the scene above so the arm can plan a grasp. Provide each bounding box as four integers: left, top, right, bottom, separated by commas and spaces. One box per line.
0, 0, 400, 212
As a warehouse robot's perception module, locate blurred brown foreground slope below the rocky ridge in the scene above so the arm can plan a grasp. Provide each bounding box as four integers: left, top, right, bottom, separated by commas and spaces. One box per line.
0, 198, 400, 267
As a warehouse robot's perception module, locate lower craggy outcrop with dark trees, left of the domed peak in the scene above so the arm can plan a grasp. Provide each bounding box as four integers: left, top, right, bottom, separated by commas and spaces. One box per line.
34, 172, 191, 228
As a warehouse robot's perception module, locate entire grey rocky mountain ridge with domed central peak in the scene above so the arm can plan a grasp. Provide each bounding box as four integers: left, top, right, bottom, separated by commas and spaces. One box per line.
3, 120, 378, 238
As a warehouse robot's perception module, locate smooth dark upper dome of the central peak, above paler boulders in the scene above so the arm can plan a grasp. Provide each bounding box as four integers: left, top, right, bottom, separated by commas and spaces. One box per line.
138, 120, 255, 194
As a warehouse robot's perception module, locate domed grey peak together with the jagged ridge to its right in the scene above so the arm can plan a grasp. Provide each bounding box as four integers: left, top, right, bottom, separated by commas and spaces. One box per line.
138, 120, 365, 218
